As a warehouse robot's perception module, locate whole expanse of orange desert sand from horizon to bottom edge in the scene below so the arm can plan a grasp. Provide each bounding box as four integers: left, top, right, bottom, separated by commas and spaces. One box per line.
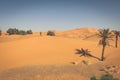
0, 28, 120, 80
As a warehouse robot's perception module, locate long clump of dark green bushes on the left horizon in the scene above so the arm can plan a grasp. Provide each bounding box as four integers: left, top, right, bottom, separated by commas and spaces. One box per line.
7, 28, 32, 35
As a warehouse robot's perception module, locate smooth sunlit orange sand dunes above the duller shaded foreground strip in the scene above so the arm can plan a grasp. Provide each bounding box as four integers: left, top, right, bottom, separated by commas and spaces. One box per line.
0, 28, 120, 79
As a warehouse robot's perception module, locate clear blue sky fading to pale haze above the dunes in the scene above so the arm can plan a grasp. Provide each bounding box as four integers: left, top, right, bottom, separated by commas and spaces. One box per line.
0, 0, 120, 31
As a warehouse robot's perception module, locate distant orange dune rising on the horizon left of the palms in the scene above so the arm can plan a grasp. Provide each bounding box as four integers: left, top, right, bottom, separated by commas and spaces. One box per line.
53, 28, 98, 38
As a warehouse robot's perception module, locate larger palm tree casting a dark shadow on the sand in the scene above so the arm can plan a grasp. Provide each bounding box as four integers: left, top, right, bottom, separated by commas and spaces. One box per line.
97, 29, 113, 61
